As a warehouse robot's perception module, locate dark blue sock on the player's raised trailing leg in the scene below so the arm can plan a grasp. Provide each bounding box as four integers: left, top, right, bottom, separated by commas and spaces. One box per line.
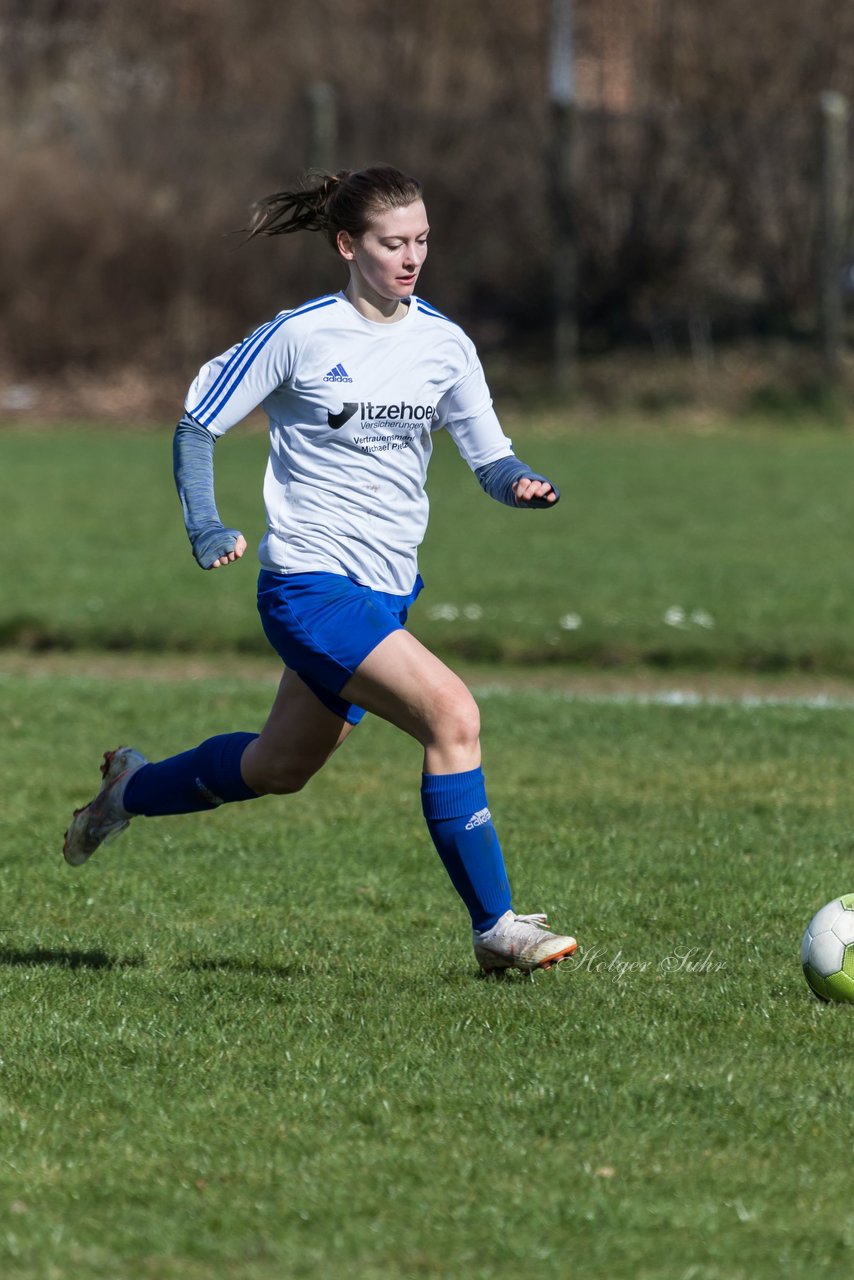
122, 733, 257, 818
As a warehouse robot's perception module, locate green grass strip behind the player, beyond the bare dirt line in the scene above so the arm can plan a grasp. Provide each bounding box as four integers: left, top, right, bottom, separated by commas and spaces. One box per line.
0, 422, 854, 675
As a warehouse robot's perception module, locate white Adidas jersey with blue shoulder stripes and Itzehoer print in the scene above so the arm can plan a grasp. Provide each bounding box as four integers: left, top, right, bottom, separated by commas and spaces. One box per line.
186, 293, 512, 595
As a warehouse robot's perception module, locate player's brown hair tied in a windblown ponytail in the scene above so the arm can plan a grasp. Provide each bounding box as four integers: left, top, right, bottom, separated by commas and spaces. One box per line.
246, 165, 421, 248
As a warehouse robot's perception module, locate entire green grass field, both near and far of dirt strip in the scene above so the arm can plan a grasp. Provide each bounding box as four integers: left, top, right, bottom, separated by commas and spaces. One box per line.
0, 414, 854, 1280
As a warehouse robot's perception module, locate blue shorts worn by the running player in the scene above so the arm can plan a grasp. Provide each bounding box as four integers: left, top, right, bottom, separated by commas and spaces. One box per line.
257, 568, 424, 724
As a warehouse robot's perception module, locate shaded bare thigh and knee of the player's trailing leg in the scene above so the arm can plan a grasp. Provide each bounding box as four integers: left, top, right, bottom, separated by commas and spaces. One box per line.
242, 669, 355, 794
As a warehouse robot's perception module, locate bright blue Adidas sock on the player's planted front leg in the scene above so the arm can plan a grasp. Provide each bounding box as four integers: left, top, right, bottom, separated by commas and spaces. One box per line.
421, 768, 511, 931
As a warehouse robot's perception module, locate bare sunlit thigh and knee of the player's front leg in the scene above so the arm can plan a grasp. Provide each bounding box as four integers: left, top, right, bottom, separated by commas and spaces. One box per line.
341, 631, 480, 746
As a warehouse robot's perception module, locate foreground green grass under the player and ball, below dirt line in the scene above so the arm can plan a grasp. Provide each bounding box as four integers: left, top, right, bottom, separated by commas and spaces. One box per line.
0, 673, 854, 1280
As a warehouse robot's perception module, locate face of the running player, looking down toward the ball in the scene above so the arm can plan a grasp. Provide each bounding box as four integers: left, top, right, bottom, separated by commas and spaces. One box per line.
338, 200, 430, 305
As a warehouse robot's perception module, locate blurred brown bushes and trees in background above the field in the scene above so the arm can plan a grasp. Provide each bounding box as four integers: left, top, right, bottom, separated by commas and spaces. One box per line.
0, 0, 854, 409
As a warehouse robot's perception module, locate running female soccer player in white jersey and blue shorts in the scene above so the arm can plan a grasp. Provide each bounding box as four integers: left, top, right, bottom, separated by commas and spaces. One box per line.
64, 166, 576, 973
